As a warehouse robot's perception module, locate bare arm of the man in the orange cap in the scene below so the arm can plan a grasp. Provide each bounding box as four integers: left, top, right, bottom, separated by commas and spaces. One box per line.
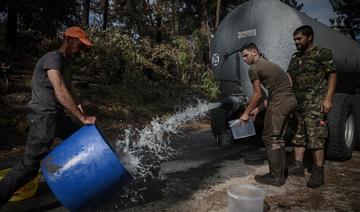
47, 69, 85, 121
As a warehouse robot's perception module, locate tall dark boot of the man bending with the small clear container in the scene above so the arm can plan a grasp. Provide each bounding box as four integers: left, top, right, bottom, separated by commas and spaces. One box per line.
255, 144, 286, 186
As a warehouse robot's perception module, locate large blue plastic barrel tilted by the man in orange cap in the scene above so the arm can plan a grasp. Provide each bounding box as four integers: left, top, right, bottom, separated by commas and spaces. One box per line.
41, 125, 132, 211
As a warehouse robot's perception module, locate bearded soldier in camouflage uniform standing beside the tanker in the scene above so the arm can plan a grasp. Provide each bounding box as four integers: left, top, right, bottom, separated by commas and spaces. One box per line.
288, 25, 336, 188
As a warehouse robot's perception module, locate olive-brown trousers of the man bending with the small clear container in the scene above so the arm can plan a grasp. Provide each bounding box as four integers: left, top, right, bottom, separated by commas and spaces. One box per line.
262, 93, 297, 150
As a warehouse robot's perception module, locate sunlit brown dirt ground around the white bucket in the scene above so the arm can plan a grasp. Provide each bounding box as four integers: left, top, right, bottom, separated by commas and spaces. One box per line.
125, 152, 360, 212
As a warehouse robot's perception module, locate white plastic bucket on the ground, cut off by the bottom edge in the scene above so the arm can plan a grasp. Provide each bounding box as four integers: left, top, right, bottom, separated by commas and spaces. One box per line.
227, 184, 265, 212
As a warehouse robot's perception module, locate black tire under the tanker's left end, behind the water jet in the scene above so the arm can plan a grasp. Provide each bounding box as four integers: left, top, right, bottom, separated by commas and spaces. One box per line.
210, 108, 233, 148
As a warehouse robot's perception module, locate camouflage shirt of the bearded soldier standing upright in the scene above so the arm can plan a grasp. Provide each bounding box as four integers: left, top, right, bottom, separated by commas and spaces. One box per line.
287, 47, 335, 111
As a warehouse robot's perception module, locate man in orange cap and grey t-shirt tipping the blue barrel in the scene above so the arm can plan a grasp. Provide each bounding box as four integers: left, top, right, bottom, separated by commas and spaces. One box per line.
0, 26, 96, 207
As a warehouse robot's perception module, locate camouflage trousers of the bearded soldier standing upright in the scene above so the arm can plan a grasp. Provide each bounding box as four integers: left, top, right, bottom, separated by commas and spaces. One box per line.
292, 108, 328, 149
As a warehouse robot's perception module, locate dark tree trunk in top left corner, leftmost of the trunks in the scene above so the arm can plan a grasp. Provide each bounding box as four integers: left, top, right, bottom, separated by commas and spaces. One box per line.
5, 5, 18, 49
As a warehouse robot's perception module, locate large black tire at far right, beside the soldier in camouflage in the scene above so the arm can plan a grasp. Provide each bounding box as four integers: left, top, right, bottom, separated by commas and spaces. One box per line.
326, 93, 356, 161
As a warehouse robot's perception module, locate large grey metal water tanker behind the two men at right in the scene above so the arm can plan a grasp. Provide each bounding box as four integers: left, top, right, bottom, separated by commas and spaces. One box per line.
210, 0, 360, 160
